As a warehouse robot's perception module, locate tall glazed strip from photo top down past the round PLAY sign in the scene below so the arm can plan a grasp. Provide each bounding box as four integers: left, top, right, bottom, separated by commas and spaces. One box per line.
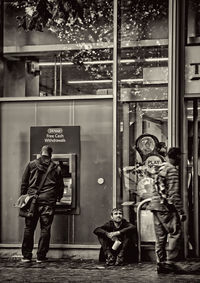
118, 0, 168, 213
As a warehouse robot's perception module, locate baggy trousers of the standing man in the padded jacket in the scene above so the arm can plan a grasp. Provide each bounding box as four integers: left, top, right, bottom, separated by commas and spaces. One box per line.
153, 211, 181, 262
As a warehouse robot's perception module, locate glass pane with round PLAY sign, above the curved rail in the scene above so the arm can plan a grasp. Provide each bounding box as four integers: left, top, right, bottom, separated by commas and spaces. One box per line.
122, 101, 168, 201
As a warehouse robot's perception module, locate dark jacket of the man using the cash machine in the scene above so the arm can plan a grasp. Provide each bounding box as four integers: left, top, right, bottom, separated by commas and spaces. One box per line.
21, 156, 64, 205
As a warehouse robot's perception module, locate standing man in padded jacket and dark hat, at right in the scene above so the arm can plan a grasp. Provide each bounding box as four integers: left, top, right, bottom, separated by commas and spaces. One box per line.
149, 147, 186, 272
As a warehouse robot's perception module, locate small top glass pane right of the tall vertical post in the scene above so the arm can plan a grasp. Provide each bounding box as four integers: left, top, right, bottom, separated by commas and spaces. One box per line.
121, 0, 168, 41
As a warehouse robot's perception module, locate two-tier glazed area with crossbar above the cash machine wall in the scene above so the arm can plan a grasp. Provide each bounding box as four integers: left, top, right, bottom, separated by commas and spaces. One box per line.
4, 0, 113, 97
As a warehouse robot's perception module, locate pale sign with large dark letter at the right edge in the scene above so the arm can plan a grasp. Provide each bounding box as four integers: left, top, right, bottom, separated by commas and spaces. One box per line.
185, 46, 200, 97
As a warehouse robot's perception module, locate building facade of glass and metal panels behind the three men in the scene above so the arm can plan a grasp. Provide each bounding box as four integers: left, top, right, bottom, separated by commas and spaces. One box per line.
0, 0, 200, 262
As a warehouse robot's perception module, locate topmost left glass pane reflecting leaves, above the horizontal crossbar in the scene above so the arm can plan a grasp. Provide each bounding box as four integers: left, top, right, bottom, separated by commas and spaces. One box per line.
4, 0, 113, 46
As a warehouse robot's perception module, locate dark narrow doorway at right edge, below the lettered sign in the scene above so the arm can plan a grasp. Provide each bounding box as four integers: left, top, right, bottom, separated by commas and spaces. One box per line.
184, 98, 200, 257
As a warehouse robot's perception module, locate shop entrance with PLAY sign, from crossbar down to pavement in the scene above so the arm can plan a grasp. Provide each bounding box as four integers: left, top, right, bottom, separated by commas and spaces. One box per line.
119, 100, 169, 261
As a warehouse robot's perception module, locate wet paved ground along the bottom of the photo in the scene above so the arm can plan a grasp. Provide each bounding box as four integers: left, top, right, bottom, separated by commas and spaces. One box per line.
0, 258, 200, 283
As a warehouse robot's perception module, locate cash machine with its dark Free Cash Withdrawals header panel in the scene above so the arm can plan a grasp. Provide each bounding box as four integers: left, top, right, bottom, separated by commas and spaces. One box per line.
30, 126, 80, 214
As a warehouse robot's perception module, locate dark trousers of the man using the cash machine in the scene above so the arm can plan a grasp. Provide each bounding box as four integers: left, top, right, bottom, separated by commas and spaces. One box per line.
22, 205, 54, 259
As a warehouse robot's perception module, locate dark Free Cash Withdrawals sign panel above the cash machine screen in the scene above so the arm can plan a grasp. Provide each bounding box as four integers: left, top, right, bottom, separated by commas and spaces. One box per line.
30, 126, 80, 158
